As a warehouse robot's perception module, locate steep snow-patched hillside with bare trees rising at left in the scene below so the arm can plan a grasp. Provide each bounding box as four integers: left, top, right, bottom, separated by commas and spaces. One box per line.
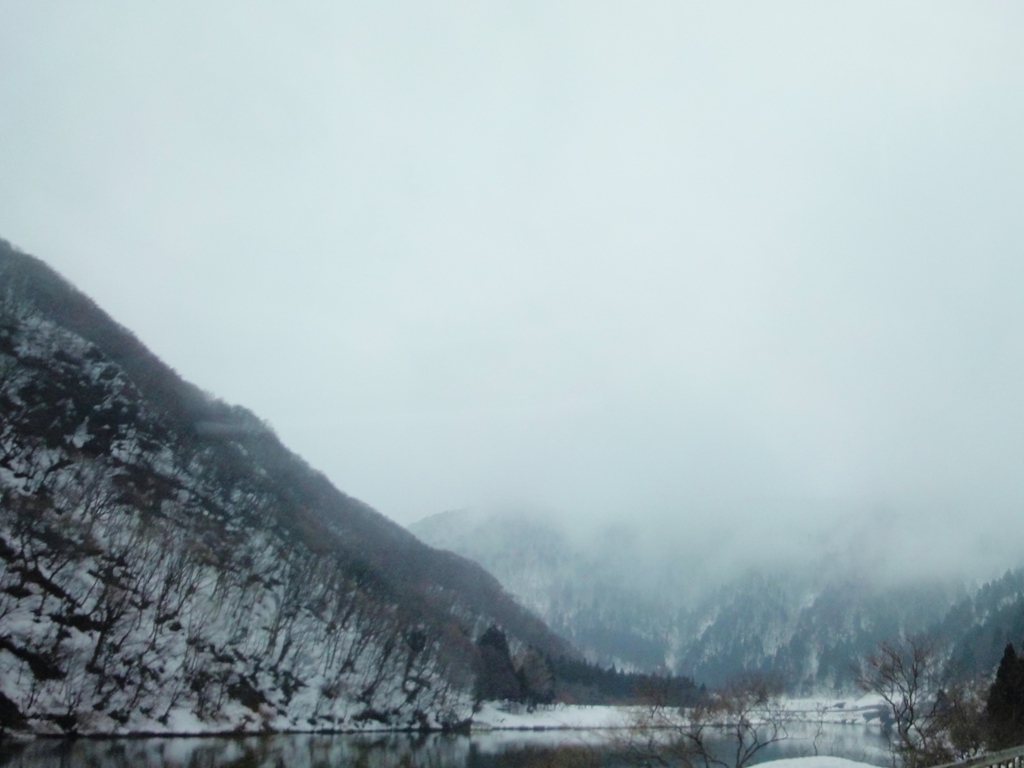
0, 241, 572, 733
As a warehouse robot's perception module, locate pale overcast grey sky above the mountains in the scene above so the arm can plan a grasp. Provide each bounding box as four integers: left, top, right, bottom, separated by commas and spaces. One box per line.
0, 0, 1024, 565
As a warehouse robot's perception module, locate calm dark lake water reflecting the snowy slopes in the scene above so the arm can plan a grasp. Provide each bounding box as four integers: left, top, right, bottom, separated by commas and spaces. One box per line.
0, 725, 887, 768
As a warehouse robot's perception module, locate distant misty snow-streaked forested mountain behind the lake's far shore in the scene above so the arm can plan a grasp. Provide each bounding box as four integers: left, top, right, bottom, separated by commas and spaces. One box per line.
412, 511, 965, 690
